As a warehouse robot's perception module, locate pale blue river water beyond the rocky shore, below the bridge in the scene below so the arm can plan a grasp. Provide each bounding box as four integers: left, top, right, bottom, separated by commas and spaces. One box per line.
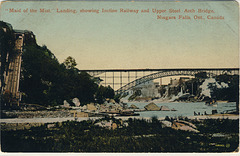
127, 102, 236, 117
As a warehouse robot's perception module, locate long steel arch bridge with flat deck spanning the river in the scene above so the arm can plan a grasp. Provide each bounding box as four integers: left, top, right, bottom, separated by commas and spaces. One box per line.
81, 68, 239, 94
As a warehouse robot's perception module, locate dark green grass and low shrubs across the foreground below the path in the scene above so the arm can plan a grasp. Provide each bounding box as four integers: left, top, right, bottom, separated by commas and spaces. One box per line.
1, 118, 239, 152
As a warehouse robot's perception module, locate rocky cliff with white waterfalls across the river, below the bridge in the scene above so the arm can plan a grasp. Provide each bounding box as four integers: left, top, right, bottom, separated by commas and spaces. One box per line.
127, 74, 239, 102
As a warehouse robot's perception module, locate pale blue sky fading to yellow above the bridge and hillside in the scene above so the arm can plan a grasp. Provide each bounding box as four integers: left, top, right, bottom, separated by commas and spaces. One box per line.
0, 2, 239, 69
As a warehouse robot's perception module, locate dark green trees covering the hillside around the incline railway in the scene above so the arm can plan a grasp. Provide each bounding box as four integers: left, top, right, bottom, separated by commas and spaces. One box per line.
0, 21, 117, 106
